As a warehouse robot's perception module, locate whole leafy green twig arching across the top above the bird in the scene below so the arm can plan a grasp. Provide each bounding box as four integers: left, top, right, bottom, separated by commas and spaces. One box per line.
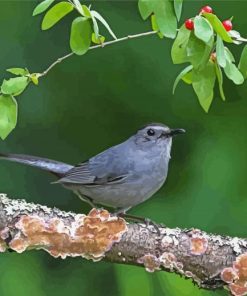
0, 0, 247, 139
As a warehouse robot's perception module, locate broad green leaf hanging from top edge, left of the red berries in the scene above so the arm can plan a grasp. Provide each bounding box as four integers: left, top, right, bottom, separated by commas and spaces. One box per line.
154, 0, 177, 39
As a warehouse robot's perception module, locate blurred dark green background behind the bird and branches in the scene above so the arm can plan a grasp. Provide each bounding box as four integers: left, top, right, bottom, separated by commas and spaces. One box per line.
0, 0, 247, 296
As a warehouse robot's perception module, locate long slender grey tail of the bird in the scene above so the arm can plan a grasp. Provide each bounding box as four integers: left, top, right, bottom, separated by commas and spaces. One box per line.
0, 153, 73, 177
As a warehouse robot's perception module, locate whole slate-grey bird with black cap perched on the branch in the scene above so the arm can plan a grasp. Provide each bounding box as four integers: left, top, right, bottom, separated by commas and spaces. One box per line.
0, 123, 185, 214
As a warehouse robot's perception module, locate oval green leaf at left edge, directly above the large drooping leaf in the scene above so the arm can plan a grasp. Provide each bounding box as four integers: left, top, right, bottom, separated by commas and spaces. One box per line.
1, 77, 29, 95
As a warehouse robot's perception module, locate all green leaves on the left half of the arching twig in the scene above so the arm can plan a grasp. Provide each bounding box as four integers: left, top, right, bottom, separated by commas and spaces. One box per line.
0, 0, 117, 140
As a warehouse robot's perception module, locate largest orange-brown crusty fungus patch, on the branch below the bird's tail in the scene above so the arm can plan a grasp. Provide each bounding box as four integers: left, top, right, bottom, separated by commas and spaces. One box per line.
9, 209, 127, 261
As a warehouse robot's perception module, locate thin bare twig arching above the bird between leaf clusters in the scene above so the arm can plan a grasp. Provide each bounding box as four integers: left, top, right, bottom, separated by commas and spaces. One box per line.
38, 31, 157, 77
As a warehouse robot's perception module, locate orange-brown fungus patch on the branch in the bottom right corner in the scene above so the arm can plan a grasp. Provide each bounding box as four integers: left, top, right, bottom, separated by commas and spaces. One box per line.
221, 253, 247, 296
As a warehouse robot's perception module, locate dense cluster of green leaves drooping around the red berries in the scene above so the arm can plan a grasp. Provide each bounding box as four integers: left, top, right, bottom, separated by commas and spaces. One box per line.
171, 13, 247, 112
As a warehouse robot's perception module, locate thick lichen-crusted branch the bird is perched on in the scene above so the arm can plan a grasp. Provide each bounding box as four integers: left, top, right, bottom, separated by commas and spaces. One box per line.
0, 194, 247, 295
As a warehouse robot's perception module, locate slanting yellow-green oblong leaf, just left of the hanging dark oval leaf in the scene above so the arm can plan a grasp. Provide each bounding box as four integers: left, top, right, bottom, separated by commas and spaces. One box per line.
41, 1, 74, 30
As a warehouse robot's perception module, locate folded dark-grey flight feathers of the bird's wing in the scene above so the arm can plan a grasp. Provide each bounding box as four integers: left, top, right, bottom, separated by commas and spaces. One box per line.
55, 161, 127, 185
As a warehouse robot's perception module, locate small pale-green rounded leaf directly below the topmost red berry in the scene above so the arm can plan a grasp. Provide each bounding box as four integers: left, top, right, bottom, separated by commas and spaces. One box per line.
194, 15, 214, 43
